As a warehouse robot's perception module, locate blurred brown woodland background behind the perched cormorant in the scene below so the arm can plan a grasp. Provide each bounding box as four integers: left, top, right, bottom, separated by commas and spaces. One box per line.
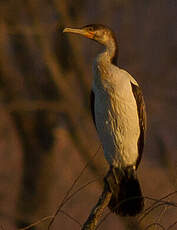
0, 0, 177, 230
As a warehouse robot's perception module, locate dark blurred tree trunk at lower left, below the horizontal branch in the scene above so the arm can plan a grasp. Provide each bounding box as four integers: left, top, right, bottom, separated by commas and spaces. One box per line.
12, 111, 57, 228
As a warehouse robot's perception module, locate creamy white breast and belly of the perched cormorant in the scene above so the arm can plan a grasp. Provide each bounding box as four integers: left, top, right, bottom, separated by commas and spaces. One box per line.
93, 60, 140, 167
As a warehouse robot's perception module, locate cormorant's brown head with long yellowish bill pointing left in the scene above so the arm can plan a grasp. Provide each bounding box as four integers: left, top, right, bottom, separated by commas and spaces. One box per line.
63, 24, 115, 45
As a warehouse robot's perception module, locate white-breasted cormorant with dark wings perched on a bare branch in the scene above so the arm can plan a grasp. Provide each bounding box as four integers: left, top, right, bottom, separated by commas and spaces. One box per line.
63, 24, 147, 216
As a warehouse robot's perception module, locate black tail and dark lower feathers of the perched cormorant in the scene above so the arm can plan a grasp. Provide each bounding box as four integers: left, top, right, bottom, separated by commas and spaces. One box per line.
106, 167, 144, 216
